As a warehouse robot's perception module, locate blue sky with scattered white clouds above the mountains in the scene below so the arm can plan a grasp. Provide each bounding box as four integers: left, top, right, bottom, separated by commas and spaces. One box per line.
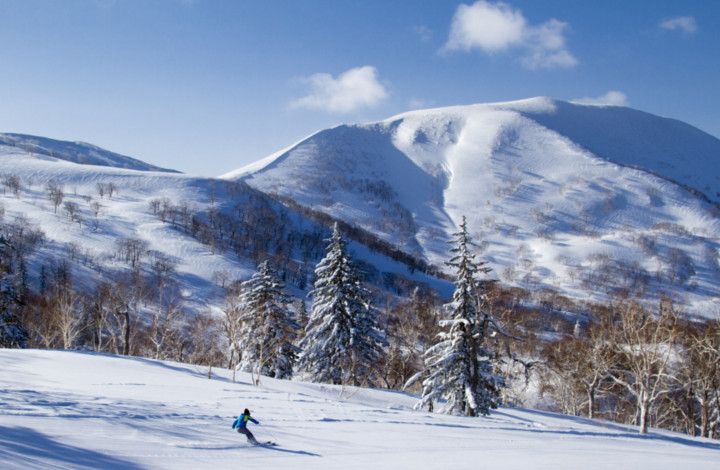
0, 0, 720, 176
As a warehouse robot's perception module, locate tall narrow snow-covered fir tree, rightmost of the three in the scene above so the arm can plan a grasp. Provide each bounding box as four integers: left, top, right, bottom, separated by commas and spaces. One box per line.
417, 217, 503, 416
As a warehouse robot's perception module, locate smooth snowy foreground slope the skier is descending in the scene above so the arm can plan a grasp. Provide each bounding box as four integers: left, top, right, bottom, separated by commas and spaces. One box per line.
0, 349, 720, 470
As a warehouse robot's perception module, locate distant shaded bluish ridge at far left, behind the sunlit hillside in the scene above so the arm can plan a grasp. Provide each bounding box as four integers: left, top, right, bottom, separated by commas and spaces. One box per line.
0, 133, 177, 173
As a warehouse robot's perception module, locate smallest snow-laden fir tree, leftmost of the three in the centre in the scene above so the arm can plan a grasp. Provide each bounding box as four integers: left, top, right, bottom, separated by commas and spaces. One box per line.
237, 261, 300, 379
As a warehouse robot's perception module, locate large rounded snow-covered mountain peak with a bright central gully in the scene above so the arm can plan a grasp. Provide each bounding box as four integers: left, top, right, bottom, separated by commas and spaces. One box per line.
223, 98, 720, 314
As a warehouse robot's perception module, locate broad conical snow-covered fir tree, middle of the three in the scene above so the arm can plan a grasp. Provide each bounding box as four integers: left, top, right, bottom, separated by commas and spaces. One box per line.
299, 223, 386, 385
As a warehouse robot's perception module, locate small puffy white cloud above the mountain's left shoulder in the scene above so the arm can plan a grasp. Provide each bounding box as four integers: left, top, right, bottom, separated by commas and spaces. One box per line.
290, 65, 389, 113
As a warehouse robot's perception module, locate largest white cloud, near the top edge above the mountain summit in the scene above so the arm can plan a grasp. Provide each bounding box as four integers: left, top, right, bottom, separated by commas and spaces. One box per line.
443, 0, 577, 69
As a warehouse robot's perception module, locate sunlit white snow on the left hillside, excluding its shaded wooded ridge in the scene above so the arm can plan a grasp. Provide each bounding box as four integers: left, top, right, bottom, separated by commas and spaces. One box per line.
0, 146, 253, 310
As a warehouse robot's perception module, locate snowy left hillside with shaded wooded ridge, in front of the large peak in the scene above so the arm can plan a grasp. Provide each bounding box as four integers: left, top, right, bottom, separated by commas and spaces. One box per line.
0, 141, 448, 312
